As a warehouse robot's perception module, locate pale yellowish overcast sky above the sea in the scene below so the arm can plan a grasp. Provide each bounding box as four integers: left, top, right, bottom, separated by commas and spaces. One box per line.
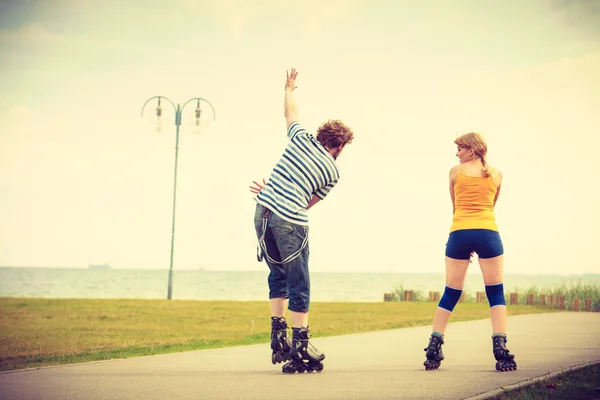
0, 0, 600, 274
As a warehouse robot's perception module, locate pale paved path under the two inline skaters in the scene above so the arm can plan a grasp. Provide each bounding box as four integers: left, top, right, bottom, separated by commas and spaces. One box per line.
0, 313, 600, 400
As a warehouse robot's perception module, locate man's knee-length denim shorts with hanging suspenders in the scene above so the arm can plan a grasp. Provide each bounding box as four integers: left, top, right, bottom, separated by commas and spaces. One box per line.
254, 204, 310, 312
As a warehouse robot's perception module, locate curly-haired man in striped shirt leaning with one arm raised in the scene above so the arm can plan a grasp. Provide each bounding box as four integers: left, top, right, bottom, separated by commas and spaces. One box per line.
251, 68, 353, 372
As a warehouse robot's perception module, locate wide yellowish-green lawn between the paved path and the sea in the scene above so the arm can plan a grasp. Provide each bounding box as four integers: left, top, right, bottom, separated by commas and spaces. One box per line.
0, 298, 549, 371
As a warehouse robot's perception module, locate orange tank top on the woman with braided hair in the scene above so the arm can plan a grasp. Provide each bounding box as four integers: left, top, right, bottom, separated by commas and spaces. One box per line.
450, 167, 498, 232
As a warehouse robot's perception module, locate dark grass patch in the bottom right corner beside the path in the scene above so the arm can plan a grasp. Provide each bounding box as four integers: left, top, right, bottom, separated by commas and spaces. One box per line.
493, 364, 600, 400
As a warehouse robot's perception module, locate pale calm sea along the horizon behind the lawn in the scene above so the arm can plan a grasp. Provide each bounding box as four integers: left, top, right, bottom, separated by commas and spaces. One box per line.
0, 267, 600, 302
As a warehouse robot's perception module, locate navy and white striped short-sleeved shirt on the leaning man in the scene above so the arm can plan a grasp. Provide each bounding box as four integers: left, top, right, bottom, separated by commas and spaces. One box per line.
256, 122, 340, 225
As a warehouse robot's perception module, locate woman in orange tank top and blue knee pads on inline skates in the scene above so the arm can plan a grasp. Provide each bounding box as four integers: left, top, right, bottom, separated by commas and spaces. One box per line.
424, 132, 517, 371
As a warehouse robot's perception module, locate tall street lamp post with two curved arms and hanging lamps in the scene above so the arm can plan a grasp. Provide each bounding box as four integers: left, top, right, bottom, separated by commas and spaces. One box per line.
142, 96, 215, 300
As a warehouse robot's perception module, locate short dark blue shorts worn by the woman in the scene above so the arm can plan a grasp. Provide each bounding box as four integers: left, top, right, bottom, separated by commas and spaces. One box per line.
446, 229, 504, 260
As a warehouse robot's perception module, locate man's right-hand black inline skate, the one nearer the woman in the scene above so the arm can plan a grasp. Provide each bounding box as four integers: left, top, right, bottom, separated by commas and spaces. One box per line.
281, 327, 325, 374
